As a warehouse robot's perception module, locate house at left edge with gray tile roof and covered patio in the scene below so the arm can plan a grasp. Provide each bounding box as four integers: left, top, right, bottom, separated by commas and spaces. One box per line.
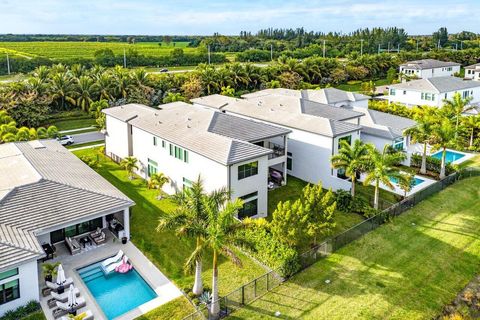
0, 140, 134, 316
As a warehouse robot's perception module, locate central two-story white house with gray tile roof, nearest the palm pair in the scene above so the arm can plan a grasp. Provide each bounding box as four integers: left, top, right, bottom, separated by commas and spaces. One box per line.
103, 102, 290, 218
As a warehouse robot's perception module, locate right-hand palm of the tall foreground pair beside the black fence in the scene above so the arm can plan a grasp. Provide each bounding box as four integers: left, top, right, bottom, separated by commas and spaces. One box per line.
202, 197, 243, 319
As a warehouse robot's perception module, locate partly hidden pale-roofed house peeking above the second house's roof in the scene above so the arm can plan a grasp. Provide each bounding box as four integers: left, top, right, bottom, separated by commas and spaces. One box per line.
242, 88, 370, 108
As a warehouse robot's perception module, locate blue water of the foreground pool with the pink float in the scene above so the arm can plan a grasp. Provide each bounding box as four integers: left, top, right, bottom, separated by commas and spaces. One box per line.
78, 263, 157, 320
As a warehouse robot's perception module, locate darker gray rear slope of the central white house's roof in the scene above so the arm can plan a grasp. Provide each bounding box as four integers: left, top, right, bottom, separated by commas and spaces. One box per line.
208, 112, 291, 142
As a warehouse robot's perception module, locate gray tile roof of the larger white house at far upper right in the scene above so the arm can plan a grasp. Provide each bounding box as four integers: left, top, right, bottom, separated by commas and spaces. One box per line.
389, 76, 480, 93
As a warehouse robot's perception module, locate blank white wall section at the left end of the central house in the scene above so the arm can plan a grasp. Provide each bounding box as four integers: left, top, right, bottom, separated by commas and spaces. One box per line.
105, 116, 129, 158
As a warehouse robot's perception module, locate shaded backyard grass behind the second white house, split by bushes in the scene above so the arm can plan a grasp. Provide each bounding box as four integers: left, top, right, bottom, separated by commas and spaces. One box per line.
267, 176, 363, 241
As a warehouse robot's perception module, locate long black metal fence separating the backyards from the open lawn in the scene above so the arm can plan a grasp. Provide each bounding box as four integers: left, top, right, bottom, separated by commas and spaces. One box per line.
183, 169, 480, 320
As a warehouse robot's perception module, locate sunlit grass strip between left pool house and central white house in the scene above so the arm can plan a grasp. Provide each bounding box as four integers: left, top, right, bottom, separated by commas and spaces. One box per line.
74, 148, 265, 295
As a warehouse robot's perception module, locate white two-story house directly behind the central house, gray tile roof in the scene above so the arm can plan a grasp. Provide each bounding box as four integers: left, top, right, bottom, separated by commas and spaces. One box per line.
192, 93, 363, 190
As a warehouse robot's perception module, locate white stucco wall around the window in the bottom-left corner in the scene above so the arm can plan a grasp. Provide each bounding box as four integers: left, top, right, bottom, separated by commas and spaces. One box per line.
0, 260, 39, 316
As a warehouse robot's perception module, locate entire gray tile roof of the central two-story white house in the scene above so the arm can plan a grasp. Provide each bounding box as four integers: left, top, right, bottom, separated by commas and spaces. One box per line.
104, 102, 280, 165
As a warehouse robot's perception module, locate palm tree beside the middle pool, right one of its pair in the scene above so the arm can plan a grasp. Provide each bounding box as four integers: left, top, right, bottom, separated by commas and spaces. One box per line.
363, 145, 405, 209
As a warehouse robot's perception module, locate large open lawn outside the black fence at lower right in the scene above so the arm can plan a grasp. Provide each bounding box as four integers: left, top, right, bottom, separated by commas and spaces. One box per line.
228, 177, 480, 319
